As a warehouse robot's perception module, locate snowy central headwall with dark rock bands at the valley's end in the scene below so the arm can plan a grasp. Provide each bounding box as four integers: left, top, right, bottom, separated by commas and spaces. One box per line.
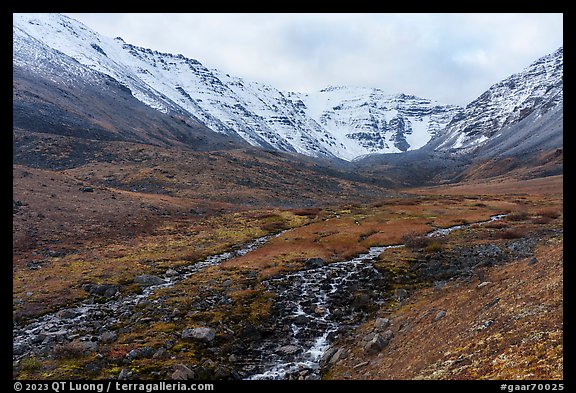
291, 87, 460, 158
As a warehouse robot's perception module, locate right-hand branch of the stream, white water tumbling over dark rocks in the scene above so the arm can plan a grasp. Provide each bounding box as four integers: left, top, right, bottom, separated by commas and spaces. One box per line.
247, 214, 505, 380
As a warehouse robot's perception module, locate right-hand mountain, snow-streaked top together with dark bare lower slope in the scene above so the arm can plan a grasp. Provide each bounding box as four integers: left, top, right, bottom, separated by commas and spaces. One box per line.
355, 48, 564, 186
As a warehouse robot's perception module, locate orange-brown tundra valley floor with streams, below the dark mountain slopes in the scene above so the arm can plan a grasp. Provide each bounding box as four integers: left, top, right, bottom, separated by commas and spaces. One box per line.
13, 172, 563, 380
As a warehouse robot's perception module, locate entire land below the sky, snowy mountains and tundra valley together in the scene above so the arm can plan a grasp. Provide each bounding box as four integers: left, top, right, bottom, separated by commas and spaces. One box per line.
11, 14, 566, 382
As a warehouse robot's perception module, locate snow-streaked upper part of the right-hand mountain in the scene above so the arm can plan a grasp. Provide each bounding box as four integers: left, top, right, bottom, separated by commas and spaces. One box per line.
433, 48, 564, 154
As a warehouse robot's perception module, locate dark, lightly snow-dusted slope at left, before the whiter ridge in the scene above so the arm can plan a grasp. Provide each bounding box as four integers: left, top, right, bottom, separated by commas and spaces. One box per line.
13, 19, 246, 150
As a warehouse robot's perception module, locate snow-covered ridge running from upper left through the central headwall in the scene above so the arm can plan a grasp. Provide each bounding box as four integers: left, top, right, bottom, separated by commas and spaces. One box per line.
13, 14, 458, 160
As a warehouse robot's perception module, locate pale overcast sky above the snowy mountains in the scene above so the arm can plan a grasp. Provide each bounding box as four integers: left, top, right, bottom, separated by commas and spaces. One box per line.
66, 13, 563, 106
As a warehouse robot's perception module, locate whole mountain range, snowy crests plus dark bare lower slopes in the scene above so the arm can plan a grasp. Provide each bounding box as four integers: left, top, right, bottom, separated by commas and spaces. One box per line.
13, 14, 563, 185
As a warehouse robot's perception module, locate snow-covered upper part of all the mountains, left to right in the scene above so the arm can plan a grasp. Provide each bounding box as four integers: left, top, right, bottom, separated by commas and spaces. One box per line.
13, 14, 563, 160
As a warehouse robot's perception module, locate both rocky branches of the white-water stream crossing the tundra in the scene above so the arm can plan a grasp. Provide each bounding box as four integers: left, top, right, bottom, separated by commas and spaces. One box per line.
13, 215, 505, 380
